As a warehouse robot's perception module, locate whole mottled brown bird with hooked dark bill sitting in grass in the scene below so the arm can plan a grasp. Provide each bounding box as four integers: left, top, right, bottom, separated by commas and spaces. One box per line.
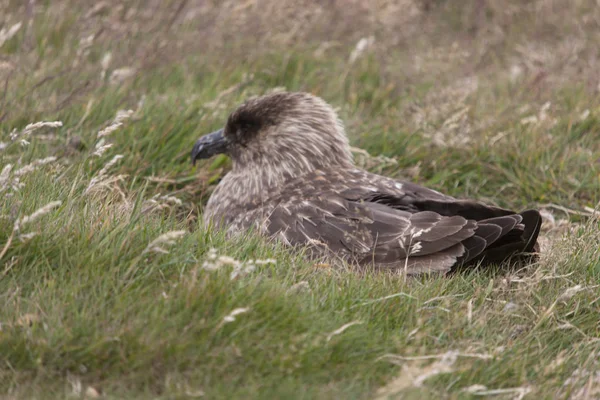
191, 91, 542, 275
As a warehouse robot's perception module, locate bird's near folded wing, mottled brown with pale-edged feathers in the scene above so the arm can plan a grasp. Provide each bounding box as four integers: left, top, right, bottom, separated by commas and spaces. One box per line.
266, 192, 520, 273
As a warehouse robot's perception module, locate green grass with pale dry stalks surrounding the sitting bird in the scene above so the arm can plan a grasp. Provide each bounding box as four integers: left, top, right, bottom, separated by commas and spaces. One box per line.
0, 2, 600, 399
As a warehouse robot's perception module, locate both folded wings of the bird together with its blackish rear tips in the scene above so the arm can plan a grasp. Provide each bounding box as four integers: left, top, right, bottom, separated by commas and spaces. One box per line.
266, 172, 539, 273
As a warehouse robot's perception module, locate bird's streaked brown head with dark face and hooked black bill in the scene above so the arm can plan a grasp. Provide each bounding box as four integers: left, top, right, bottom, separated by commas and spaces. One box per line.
192, 92, 353, 175
